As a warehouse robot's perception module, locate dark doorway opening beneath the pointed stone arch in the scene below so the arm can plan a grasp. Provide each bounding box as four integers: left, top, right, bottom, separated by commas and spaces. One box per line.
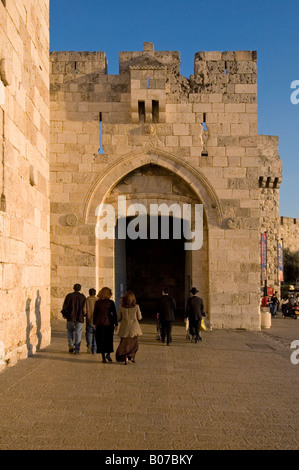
115, 216, 191, 322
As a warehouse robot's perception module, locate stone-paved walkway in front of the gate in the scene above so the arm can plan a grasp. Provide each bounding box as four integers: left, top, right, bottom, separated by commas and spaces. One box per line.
0, 318, 299, 450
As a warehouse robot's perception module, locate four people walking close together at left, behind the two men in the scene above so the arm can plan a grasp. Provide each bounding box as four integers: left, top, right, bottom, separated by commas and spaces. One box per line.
61, 284, 142, 364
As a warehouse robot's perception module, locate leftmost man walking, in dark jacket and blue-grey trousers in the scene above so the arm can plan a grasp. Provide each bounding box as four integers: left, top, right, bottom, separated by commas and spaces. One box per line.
61, 284, 86, 354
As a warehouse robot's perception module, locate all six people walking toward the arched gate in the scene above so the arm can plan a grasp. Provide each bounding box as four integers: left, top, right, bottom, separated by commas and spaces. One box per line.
61, 284, 205, 364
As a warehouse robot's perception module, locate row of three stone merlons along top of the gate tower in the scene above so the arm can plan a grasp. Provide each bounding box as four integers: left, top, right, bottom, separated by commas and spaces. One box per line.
50, 42, 257, 84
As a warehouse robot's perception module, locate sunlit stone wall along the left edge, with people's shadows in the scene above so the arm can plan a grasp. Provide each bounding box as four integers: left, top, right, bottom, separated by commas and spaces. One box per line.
0, 0, 50, 368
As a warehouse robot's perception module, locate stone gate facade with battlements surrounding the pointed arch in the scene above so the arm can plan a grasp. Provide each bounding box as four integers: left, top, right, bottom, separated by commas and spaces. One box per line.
51, 43, 280, 329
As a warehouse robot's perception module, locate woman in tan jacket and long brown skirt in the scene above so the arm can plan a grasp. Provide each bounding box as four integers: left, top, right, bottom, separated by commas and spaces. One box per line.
115, 291, 142, 364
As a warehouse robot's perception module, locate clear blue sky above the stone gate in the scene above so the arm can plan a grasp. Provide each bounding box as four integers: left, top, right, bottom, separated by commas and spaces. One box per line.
50, 0, 299, 218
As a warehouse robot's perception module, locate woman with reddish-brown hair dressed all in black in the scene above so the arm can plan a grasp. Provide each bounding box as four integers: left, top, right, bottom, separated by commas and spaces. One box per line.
93, 287, 117, 363
